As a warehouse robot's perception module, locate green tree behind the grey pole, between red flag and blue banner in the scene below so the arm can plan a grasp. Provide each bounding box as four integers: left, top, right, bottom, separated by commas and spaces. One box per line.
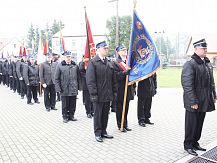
106, 16, 132, 55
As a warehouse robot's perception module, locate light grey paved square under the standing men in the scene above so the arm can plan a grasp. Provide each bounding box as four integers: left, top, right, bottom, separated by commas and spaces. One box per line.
0, 85, 217, 163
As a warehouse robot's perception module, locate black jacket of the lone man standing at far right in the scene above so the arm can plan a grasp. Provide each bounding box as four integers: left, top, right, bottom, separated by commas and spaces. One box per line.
181, 53, 216, 112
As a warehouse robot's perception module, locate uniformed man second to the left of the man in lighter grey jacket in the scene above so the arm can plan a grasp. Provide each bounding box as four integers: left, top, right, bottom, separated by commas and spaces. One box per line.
16, 54, 28, 99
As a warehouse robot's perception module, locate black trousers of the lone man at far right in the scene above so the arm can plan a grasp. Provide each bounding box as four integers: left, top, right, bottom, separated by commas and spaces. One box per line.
184, 110, 206, 149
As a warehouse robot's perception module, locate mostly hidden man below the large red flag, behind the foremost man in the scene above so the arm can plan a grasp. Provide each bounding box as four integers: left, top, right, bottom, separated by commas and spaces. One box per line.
79, 60, 93, 118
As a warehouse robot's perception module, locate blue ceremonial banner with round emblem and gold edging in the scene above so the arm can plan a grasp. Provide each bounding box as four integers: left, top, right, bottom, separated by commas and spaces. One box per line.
128, 9, 160, 85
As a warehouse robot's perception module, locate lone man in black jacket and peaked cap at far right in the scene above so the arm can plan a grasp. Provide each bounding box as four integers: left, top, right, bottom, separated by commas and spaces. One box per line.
181, 39, 216, 156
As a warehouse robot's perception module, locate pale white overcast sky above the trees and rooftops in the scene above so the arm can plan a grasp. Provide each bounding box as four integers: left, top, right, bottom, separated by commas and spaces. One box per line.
0, 0, 217, 38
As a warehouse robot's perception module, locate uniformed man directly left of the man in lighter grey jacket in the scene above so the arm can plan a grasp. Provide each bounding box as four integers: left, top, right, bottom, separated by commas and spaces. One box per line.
23, 56, 40, 105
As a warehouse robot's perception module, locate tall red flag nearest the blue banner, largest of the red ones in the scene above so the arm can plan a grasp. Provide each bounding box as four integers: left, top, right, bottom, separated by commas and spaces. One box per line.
84, 10, 96, 67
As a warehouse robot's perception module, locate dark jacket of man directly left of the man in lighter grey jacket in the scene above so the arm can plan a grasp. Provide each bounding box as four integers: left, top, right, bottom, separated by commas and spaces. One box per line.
23, 63, 39, 86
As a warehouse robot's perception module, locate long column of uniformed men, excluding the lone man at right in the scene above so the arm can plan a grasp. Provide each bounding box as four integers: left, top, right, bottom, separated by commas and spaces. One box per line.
0, 41, 157, 142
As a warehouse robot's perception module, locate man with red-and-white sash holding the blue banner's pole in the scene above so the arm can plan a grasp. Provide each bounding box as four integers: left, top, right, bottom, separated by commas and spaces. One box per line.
114, 45, 135, 132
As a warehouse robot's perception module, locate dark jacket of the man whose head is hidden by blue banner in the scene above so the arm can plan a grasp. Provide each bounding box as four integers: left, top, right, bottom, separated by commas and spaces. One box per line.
137, 73, 157, 98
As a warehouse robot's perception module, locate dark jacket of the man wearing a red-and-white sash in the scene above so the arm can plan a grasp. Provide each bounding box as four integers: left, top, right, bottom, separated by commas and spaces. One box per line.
113, 58, 135, 101
